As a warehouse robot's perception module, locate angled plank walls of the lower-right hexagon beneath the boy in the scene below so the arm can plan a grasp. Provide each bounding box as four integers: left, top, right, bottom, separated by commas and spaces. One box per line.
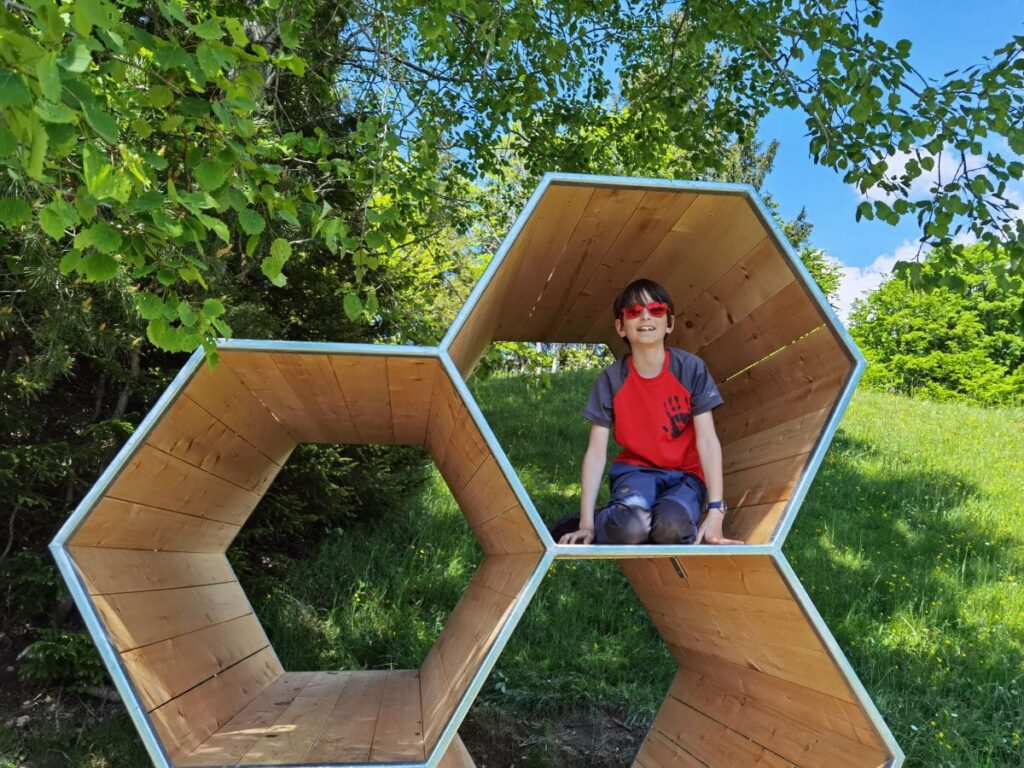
621, 555, 902, 768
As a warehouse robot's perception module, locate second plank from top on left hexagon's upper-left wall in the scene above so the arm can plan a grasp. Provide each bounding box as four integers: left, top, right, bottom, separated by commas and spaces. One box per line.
145, 396, 281, 496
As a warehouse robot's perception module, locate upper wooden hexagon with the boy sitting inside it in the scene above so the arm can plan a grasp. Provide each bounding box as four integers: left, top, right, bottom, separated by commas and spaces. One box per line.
444, 175, 859, 544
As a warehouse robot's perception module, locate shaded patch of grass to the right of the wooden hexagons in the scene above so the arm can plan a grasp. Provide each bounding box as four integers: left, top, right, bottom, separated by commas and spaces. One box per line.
784, 431, 1024, 768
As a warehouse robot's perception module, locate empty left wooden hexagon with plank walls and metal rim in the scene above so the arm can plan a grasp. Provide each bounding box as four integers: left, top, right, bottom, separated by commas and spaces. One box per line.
54, 343, 547, 765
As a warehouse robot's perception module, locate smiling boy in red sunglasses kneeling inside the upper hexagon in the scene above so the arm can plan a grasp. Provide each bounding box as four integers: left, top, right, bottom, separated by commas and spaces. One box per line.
558, 280, 742, 544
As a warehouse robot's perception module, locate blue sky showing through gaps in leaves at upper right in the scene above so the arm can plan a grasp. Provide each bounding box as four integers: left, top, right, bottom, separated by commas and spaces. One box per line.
760, 0, 1024, 314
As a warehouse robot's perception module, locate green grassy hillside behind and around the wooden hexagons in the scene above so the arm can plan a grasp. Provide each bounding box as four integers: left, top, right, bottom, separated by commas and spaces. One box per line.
0, 380, 1024, 768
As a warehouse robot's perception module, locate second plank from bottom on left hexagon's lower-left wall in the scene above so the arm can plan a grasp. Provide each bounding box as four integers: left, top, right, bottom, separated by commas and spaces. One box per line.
121, 618, 270, 711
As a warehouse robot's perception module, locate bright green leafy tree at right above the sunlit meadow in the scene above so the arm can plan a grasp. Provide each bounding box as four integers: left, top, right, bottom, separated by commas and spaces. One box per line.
850, 245, 1024, 406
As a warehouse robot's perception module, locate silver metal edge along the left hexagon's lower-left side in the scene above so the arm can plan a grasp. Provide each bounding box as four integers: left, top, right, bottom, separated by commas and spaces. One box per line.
50, 544, 174, 768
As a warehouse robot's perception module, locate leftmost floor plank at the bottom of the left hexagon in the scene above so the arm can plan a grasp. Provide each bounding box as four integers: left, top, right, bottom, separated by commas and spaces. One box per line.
180, 672, 314, 766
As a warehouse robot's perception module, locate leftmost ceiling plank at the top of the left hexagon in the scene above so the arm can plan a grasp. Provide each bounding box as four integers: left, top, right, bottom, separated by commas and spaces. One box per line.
219, 349, 331, 442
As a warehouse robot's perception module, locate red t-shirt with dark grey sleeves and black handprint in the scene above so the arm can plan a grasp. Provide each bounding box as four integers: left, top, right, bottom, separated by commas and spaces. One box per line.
583, 347, 723, 481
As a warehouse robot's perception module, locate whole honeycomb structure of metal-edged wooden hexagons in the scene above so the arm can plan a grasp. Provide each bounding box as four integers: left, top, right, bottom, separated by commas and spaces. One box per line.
52, 175, 902, 768
